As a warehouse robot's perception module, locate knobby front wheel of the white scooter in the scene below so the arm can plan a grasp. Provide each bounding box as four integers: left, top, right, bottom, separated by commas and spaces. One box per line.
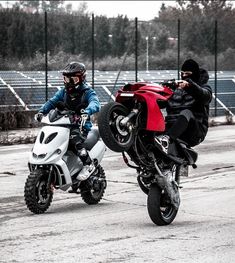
24, 170, 53, 214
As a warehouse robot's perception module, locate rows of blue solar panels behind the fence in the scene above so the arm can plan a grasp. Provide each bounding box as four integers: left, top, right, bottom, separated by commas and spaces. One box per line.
0, 70, 235, 116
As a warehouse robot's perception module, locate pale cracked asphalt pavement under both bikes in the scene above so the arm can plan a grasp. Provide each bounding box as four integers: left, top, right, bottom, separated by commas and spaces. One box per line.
0, 125, 235, 263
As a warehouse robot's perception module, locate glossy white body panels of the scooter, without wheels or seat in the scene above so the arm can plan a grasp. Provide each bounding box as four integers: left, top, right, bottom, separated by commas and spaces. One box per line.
29, 115, 106, 190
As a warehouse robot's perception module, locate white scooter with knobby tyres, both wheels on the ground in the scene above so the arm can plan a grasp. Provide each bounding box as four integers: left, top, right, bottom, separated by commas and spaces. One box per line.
24, 103, 107, 214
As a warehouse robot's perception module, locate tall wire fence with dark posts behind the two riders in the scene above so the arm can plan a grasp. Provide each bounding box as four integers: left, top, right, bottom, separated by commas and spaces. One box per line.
0, 7, 235, 130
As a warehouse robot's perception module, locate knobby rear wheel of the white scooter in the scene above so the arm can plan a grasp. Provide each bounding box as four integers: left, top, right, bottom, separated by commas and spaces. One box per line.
80, 165, 107, 205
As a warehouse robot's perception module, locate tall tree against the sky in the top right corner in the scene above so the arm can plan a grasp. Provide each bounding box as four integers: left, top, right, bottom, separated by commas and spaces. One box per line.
158, 0, 235, 54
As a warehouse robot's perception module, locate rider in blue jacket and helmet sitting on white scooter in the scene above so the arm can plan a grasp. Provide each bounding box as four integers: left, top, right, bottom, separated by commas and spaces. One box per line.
35, 62, 100, 186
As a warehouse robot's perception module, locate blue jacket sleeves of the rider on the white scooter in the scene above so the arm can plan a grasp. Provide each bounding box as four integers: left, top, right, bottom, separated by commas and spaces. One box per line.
39, 82, 100, 131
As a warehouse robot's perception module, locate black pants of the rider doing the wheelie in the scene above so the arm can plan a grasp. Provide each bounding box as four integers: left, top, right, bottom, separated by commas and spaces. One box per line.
166, 109, 204, 146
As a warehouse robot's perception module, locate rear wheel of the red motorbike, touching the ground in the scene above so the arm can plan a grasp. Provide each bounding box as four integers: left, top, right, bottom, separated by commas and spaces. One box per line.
147, 184, 178, 226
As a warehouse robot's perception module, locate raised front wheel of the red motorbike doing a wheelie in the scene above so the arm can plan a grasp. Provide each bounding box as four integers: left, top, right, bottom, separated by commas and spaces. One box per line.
98, 102, 134, 152
